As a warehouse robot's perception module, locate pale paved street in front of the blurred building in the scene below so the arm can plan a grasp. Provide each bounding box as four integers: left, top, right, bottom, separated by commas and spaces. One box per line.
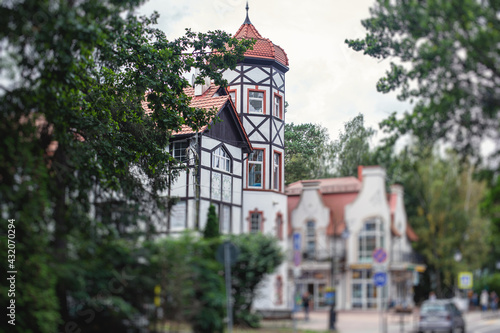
290, 311, 500, 333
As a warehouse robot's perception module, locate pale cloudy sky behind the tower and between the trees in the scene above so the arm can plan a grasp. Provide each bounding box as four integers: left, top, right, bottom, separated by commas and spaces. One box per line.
139, 0, 411, 140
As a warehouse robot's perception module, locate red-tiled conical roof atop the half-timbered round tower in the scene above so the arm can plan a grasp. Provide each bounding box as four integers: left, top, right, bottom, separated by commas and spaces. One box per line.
234, 21, 288, 66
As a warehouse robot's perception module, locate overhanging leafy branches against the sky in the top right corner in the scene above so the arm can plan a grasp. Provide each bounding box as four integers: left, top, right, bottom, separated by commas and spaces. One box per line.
346, 0, 500, 156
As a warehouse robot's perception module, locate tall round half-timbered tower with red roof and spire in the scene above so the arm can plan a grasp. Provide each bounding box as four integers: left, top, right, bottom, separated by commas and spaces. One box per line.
224, 3, 290, 309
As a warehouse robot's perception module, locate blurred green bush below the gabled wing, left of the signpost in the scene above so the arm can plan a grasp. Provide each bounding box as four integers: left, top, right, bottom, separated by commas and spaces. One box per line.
150, 234, 225, 333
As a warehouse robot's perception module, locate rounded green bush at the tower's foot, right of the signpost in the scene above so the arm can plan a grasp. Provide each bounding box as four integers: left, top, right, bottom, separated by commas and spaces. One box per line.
230, 233, 284, 327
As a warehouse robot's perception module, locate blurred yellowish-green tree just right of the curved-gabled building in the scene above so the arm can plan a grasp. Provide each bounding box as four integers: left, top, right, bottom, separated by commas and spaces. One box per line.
404, 147, 488, 296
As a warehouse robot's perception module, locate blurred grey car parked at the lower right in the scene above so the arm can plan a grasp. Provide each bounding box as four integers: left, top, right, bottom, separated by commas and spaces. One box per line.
418, 299, 465, 333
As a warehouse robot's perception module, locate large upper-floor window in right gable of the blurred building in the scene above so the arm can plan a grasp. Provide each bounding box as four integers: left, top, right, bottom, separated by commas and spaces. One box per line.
358, 217, 385, 262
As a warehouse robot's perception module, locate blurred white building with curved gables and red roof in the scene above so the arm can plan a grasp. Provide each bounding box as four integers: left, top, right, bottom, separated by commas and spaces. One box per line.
286, 166, 425, 310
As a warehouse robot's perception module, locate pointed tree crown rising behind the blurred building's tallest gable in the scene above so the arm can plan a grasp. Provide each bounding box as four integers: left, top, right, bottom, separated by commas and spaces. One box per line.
332, 113, 375, 177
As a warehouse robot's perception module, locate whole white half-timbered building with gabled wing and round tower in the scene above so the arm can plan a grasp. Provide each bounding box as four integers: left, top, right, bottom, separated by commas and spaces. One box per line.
160, 5, 290, 310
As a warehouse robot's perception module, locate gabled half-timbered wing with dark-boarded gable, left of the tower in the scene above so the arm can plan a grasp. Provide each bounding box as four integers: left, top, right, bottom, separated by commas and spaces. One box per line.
162, 83, 252, 234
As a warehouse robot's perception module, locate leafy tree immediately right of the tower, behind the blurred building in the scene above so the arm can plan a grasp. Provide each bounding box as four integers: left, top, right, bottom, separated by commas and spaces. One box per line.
285, 123, 330, 184
